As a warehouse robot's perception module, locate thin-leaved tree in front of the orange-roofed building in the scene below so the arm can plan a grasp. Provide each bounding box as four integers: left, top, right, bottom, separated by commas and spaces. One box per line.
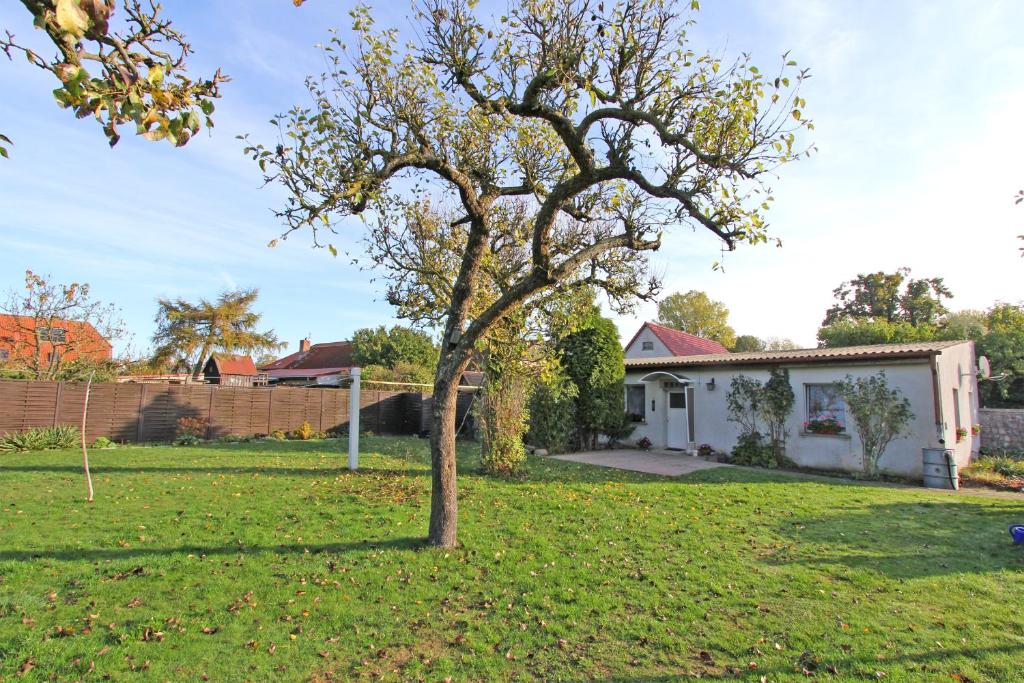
0, 270, 127, 381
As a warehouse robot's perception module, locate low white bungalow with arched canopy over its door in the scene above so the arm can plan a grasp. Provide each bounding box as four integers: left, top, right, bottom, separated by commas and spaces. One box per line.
625, 337, 980, 477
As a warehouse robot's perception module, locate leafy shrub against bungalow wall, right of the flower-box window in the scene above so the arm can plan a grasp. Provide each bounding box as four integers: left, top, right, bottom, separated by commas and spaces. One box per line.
836, 370, 913, 477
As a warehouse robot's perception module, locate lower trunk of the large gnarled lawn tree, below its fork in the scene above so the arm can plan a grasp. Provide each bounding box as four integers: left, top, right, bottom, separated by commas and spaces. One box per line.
427, 350, 469, 548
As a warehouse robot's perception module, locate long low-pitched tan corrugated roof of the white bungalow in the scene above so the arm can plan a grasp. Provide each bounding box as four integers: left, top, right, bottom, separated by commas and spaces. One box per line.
626, 341, 967, 369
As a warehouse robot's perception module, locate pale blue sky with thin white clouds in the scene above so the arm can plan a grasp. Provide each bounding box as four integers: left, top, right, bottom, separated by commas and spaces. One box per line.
0, 0, 1024, 358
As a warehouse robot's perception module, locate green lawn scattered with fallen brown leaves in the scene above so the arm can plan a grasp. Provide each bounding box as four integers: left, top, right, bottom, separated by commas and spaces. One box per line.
0, 437, 1024, 682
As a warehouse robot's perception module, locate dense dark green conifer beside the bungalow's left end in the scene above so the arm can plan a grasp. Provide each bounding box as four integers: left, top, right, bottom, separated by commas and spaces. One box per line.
558, 308, 626, 449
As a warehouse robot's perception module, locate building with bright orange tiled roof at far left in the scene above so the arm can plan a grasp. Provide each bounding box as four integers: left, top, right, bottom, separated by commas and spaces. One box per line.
0, 313, 114, 368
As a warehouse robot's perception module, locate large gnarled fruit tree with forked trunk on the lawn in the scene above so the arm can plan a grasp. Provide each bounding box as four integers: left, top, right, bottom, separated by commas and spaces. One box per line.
248, 0, 808, 547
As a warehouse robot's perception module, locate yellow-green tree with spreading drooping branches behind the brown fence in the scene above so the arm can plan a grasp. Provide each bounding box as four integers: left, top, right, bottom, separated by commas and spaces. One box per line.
153, 288, 284, 380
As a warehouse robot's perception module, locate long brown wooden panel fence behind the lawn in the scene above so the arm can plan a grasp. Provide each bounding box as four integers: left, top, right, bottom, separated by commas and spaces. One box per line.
0, 380, 460, 442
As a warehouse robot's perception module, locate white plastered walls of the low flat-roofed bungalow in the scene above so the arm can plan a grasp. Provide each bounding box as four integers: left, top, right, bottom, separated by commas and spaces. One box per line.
626, 344, 979, 477
